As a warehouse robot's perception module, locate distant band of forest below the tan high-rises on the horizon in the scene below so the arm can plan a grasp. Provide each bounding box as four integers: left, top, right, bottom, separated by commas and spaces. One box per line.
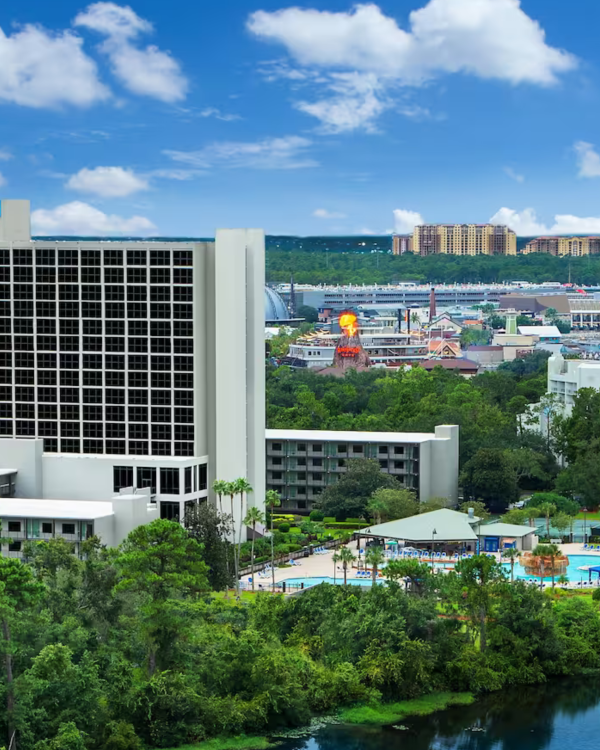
267, 248, 600, 284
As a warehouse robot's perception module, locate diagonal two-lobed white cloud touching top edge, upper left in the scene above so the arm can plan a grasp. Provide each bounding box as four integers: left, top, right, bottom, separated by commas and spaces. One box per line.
73, 2, 189, 102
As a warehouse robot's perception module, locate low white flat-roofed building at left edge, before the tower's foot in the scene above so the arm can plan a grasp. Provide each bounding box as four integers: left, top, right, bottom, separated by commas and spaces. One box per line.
0, 490, 158, 557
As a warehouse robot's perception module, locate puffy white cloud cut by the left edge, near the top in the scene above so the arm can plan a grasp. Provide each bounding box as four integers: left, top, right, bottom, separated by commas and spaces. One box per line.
0, 25, 110, 109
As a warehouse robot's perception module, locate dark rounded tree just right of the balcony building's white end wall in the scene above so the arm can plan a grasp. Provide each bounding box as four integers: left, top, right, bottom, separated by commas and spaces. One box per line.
460, 448, 518, 510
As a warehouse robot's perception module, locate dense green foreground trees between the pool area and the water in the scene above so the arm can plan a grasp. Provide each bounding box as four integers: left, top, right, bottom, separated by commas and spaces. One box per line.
7, 520, 600, 750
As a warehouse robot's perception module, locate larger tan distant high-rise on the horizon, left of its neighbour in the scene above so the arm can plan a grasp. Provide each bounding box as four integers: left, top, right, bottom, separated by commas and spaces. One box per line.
411, 224, 517, 255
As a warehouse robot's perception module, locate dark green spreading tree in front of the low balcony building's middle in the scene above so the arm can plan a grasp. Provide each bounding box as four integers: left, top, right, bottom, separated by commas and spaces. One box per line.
317, 458, 402, 521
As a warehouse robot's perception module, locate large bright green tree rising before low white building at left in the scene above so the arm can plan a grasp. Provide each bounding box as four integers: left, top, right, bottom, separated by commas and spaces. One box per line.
115, 519, 208, 677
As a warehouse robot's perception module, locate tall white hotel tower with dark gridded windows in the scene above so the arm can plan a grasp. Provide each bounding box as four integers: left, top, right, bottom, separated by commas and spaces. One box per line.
0, 200, 265, 518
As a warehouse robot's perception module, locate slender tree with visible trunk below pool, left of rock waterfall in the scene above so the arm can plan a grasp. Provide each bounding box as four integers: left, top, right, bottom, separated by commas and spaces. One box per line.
455, 555, 504, 653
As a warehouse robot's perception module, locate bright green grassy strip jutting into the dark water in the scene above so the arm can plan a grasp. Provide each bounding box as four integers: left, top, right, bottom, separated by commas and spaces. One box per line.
340, 693, 475, 725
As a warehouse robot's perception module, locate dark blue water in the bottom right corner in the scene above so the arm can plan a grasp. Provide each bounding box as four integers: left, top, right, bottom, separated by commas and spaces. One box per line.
280, 677, 600, 750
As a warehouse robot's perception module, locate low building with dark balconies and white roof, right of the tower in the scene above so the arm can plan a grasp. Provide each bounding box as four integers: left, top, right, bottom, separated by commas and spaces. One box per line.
267, 425, 459, 512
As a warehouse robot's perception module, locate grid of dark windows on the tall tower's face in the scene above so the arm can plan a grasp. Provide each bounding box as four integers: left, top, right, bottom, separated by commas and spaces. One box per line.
0, 243, 197, 456
